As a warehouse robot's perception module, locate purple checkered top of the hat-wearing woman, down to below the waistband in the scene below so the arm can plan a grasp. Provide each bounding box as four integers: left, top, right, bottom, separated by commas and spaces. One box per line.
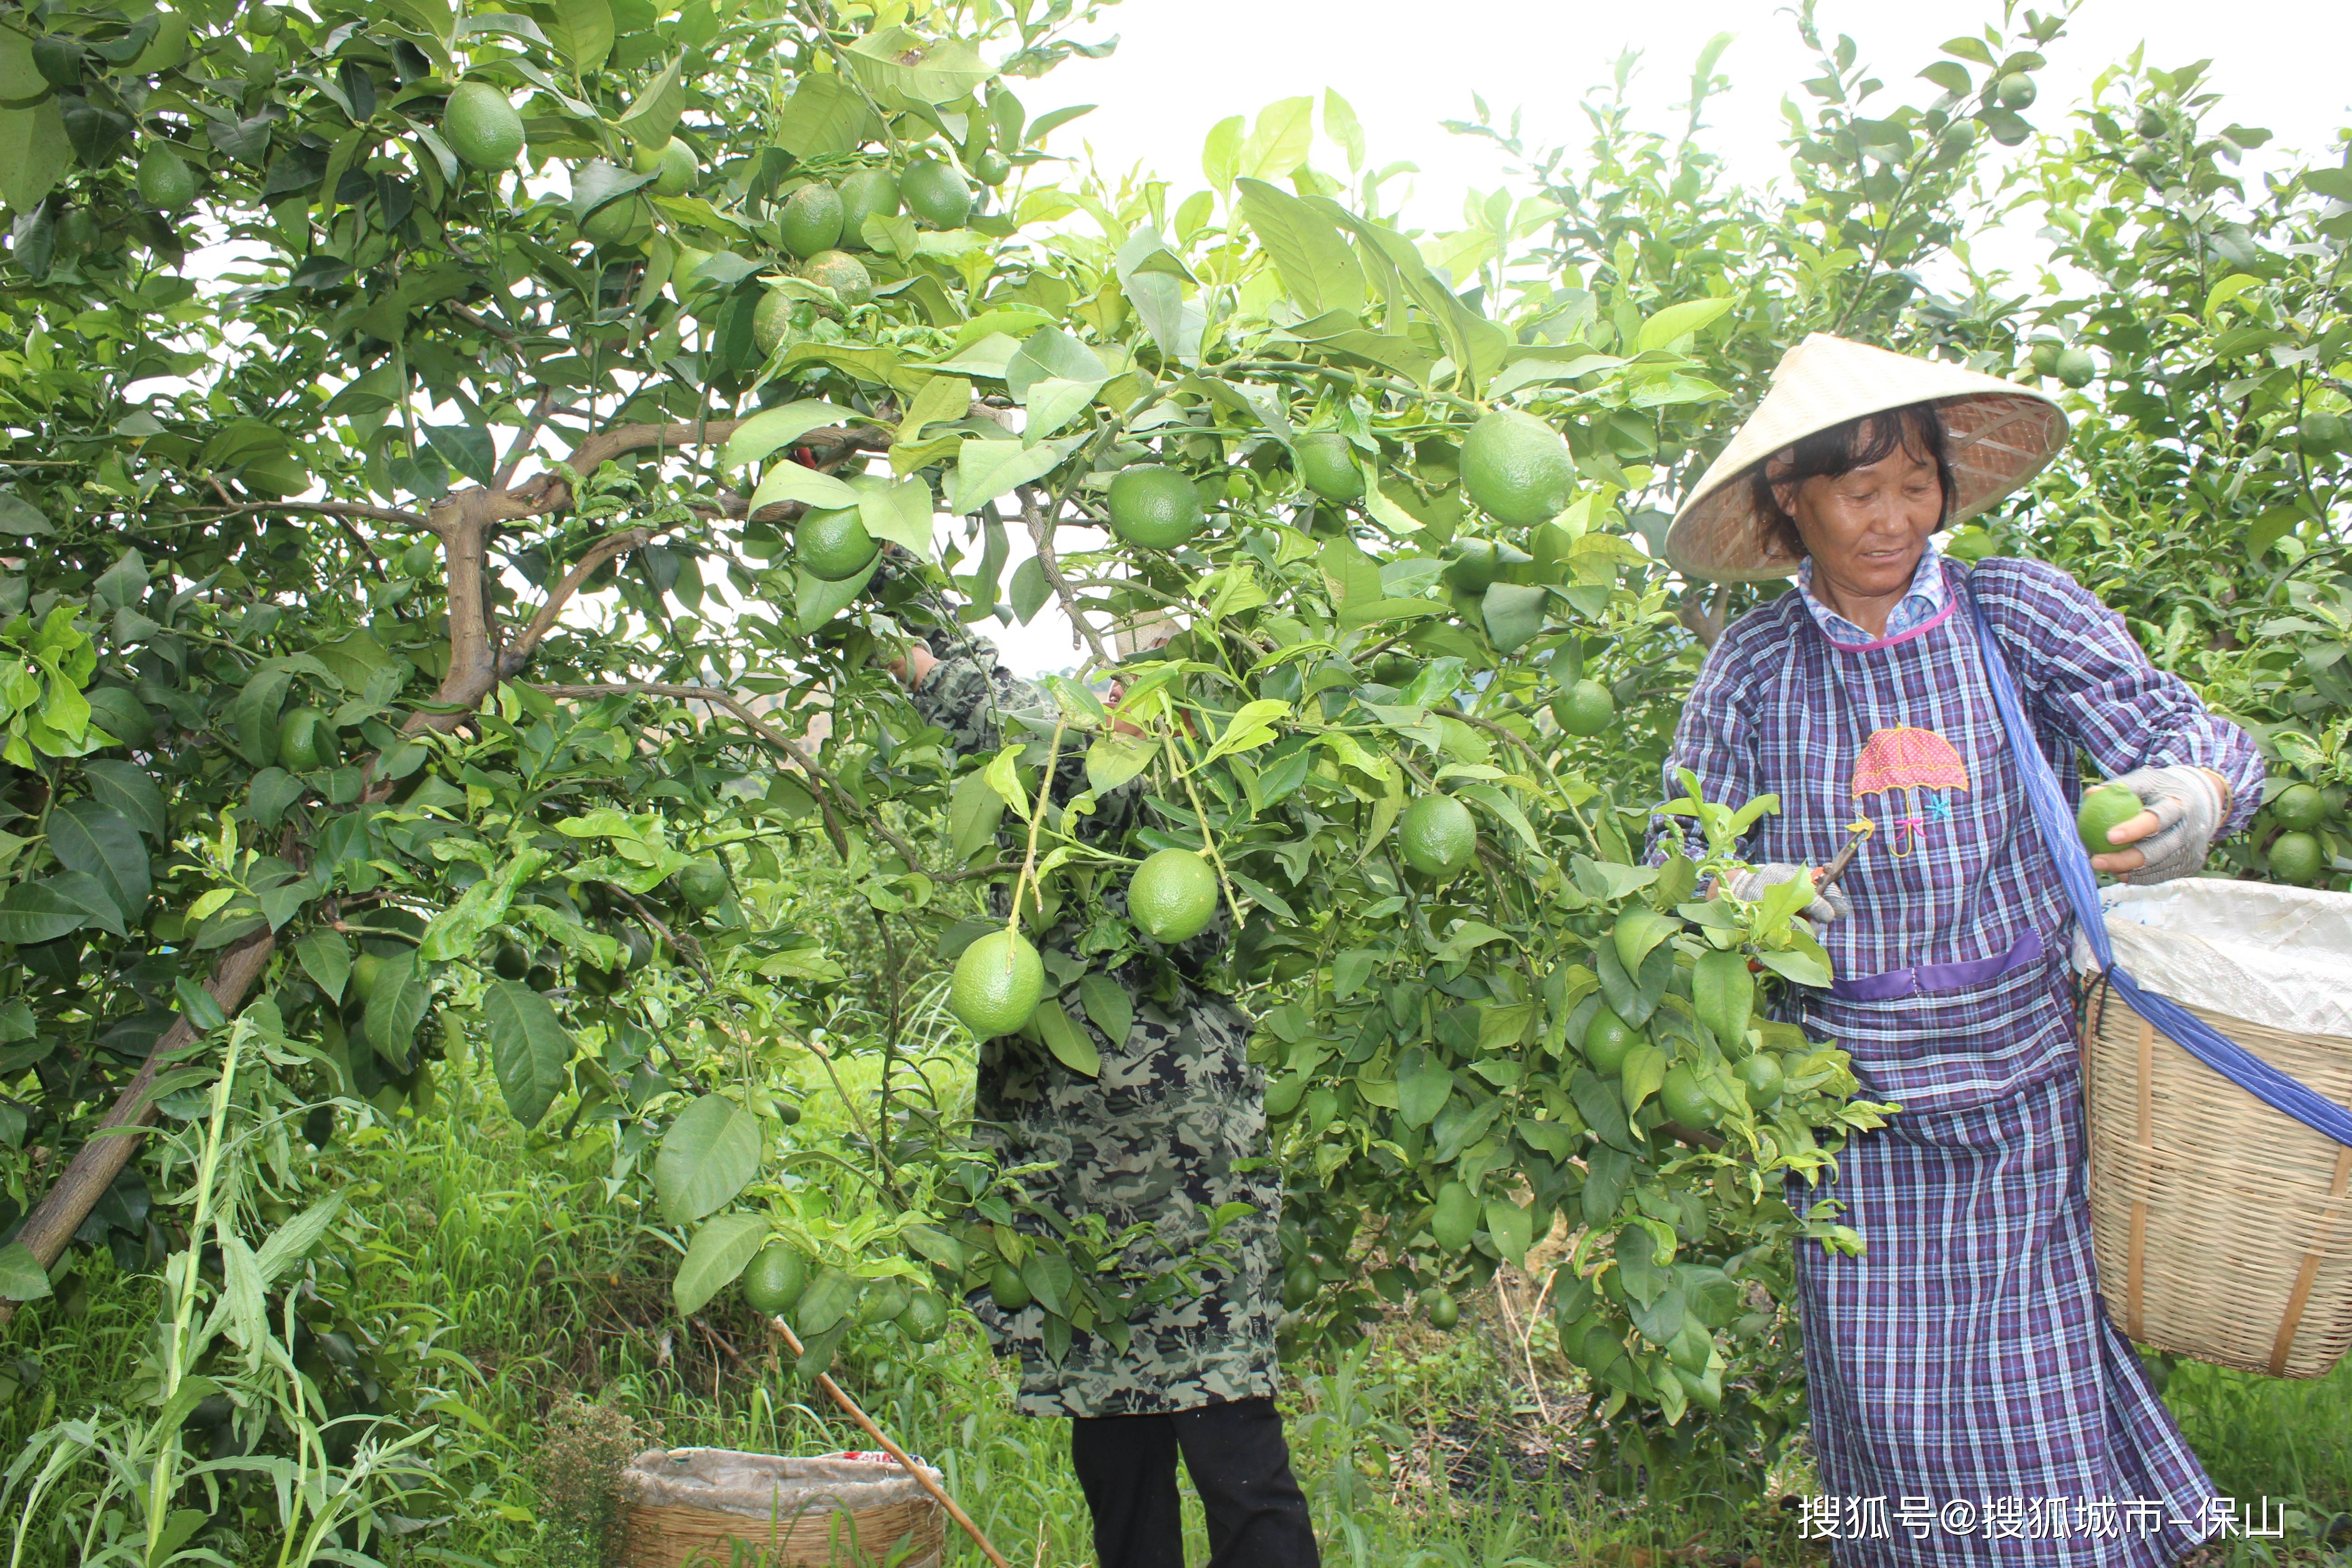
1651, 557, 2263, 1110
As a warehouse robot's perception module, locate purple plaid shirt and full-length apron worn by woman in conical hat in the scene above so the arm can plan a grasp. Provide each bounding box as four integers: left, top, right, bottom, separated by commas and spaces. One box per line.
1665, 559, 2263, 1568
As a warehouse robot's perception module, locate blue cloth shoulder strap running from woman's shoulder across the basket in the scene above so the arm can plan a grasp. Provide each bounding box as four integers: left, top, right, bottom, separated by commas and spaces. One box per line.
1966, 571, 2352, 1147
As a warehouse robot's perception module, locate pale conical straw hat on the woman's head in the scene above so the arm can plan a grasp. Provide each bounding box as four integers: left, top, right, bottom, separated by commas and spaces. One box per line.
1665, 332, 2065, 583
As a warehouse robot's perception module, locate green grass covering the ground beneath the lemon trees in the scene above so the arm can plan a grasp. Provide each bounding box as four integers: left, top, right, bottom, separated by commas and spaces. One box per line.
0, 1044, 2352, 1568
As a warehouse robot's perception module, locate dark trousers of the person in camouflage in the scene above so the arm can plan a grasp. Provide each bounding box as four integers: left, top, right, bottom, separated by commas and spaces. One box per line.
1070, 1399, 1322, 1568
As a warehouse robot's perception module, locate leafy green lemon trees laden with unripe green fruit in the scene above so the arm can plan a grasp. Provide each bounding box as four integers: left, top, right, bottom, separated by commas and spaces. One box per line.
0, 0, 2352, 1563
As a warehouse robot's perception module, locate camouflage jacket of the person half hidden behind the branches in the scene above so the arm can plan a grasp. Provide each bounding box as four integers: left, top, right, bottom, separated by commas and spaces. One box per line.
915, 635, 1282, 1415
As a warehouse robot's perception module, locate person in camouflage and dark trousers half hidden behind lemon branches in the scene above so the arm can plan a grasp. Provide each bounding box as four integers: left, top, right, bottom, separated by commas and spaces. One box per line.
896, 630, 1319, 1568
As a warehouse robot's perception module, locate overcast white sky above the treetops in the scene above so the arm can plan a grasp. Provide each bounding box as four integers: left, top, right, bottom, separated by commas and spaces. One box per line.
964, 0, 2352, 672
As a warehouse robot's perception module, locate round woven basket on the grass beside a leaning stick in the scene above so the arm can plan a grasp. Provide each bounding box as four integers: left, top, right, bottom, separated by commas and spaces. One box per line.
621, 1448, 946, 1568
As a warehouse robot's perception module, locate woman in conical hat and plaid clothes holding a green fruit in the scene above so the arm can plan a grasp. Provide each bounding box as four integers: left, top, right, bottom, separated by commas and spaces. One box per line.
1656, 334, 2263, 1566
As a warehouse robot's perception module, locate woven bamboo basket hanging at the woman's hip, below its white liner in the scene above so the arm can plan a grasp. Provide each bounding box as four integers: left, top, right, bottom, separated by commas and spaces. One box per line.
2082, 983, 2352, 1377
